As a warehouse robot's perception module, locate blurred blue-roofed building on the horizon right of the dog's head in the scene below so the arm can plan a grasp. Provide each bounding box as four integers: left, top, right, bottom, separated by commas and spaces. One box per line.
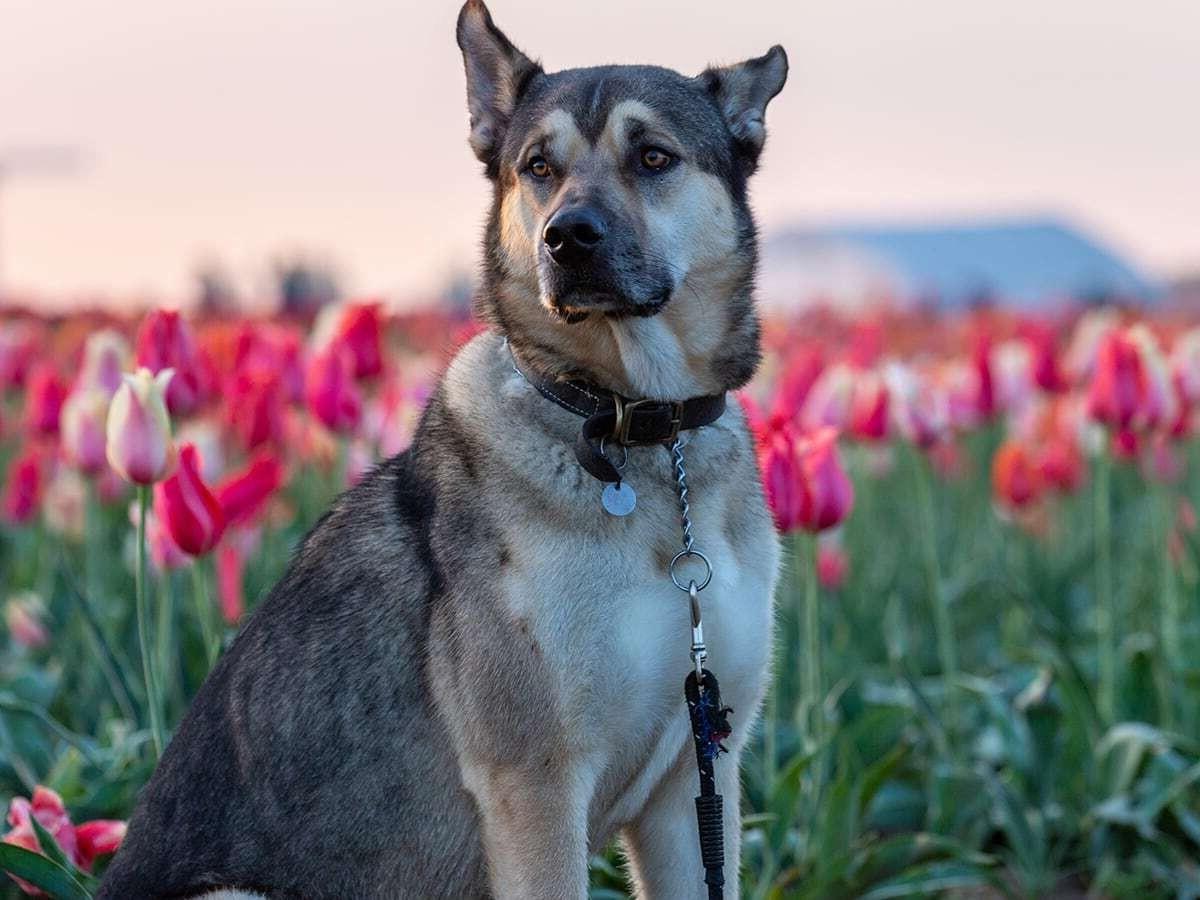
760, 217, 1164, 308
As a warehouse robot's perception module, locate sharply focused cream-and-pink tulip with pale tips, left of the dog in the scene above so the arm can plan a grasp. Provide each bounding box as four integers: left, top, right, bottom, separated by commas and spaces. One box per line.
107, 368, 174, 486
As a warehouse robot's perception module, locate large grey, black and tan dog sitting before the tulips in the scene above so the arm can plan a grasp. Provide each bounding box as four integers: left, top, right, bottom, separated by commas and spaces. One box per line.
98, 0, 787, 900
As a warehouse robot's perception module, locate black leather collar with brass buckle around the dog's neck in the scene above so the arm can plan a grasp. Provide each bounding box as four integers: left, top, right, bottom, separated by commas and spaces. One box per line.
512, 354, 725, 482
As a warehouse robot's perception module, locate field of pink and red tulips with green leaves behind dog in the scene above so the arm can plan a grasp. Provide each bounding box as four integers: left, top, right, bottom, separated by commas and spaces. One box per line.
0, 302, 1200, 900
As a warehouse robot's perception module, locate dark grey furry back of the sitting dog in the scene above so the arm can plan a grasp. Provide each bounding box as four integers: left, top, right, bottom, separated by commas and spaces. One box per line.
97, 454, 486, 900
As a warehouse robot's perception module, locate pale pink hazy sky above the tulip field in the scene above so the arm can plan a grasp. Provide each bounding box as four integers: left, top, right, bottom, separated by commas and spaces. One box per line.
0, 0, 1200, 307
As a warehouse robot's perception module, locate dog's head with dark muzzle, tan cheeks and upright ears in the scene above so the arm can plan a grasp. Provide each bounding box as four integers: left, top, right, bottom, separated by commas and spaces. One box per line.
458, 0, 787, 396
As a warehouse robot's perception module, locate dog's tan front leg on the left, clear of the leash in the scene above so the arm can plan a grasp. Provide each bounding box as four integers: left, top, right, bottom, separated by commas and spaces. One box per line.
472, 760, 588, 900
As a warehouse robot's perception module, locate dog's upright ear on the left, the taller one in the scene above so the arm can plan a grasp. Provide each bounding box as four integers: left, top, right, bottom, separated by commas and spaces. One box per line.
457, 0, 541, 170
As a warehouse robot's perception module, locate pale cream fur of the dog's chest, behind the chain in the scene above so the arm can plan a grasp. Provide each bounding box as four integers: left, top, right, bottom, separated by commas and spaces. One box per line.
489, 441, 778, 835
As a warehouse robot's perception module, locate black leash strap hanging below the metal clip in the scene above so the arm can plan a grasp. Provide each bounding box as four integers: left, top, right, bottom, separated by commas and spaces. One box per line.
683, 668, 733, 900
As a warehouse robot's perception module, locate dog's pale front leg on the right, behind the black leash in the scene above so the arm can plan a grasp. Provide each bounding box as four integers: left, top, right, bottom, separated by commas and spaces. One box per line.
622, 743, 742, 900
